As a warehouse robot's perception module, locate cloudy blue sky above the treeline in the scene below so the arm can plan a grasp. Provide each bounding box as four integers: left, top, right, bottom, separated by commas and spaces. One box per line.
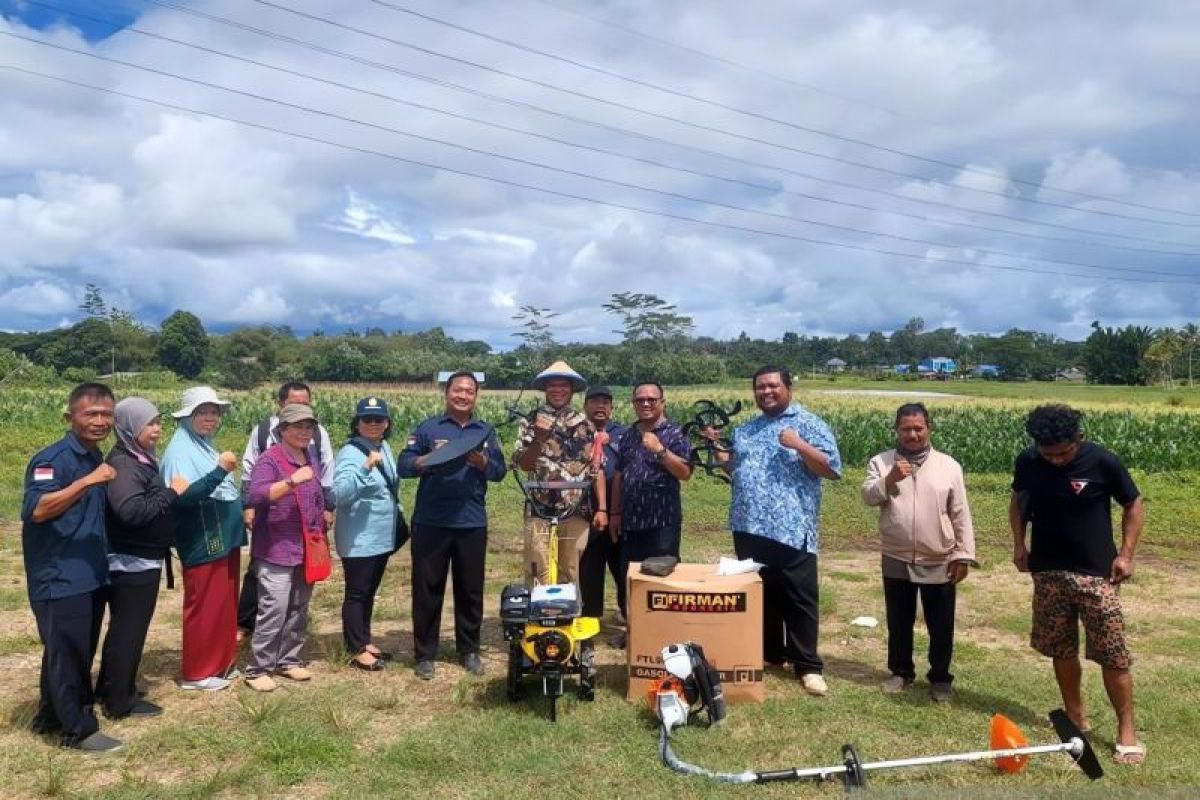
0, 0, 1200, 345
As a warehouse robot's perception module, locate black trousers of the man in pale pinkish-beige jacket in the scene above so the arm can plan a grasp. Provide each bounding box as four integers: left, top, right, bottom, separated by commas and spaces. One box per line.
883, 578, 958, 684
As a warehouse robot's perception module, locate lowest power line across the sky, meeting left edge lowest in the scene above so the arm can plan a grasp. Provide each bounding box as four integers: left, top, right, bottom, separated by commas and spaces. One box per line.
0, 65, 1200, 285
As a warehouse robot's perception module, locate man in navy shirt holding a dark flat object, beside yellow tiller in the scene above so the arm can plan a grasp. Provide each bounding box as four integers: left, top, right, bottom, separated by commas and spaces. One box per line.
396, 371, 508, 680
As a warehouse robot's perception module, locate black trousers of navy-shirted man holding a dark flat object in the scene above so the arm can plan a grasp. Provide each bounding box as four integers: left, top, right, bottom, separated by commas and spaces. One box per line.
410, 523, 487, 661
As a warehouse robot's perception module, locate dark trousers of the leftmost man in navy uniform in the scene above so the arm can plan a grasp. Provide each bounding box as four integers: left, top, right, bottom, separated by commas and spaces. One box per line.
30, 588, 104, 746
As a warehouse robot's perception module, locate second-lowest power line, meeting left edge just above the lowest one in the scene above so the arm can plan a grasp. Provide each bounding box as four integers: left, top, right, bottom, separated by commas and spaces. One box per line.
11, 31, 1187, 277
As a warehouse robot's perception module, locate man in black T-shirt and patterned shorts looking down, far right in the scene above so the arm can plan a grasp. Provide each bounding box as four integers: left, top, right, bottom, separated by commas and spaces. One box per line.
1008, 405, 1146, 764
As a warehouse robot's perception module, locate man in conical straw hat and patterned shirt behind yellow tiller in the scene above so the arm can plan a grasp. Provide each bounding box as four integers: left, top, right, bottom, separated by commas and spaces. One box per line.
512, 361, 608, 583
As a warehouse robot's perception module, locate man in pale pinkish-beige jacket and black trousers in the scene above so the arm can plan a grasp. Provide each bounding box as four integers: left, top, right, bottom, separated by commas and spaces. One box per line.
863, 403, 979, 703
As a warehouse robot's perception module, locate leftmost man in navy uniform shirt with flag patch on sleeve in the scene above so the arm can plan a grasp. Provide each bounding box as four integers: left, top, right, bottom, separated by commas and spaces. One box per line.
20, 384, 121, 752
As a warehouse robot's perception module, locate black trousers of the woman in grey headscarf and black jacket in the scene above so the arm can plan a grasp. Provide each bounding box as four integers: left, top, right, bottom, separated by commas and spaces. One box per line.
96, 569, 162, 717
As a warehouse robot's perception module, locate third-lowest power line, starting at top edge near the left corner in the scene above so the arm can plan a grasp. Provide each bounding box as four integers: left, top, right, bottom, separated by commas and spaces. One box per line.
26, 0, 1200, 255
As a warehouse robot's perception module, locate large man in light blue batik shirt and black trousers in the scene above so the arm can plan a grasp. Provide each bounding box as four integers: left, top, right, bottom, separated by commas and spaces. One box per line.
708, 366, 841, 696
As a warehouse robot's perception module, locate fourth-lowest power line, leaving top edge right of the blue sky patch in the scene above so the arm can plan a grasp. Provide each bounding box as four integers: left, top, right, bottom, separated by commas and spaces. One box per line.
119, 0, 1188, 247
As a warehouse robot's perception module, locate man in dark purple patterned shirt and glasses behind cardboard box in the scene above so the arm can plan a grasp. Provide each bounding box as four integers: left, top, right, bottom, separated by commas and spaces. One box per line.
608, 380, 691, 646
